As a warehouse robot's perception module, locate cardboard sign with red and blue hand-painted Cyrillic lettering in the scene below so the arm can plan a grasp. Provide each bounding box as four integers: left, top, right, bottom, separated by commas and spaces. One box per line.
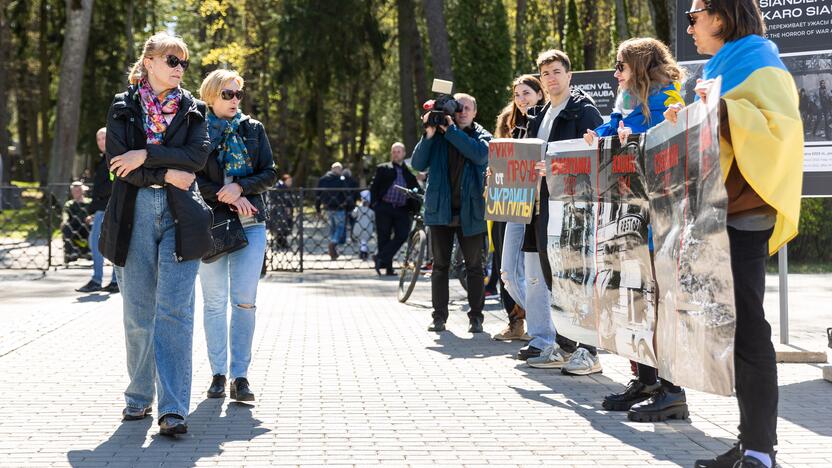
485, 138, 546, 224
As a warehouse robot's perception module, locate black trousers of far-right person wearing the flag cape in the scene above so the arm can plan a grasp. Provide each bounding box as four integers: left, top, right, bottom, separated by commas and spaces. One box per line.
728, 227, 778, 453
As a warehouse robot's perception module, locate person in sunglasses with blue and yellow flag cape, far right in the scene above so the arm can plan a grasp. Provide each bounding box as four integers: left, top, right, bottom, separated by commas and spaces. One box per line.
665, 0, 803, 468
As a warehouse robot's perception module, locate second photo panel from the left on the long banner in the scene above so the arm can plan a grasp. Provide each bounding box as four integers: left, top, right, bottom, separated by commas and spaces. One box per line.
595, 135, 657, 367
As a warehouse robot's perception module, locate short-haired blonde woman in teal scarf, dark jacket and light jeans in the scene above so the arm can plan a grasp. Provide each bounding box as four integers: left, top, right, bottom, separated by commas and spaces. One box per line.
197, 70, 277, 401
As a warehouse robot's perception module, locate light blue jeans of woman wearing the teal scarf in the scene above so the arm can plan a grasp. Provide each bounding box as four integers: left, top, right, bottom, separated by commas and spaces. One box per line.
199, 224, 266, 380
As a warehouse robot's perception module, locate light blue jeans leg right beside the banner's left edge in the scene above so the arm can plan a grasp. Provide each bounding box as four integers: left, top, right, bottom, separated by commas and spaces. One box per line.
522, 252, 557, 349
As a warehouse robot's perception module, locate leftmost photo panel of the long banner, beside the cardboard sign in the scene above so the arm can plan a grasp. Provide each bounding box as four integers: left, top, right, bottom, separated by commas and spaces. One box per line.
546, 140, 599, 346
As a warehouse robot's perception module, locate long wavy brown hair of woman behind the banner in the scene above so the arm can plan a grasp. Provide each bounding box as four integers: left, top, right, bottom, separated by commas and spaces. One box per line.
618, 37, 685, 121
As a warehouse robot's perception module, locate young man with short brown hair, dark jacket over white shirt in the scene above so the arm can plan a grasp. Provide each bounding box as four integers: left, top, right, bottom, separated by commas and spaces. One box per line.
520, 49, 604, 375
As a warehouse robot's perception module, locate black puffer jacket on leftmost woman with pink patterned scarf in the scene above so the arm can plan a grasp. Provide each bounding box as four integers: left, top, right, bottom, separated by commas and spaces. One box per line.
99, 86, 212, 266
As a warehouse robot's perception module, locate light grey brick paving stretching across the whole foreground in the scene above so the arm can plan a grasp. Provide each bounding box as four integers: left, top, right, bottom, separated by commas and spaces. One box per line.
0, 270, 832, 467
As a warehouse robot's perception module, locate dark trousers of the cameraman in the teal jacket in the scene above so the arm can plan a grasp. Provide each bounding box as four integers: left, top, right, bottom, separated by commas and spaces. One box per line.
428, 226, 485, 322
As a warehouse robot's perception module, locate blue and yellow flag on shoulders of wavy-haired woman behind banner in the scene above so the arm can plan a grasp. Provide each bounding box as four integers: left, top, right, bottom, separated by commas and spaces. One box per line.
595, 81, 685, 137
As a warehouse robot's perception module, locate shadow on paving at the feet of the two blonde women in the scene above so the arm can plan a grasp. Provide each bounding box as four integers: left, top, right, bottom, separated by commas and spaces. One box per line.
67, 399, 270, 467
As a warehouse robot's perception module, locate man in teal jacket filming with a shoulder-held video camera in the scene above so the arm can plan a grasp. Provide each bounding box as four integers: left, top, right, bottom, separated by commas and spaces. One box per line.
412, 89, 491, 333
